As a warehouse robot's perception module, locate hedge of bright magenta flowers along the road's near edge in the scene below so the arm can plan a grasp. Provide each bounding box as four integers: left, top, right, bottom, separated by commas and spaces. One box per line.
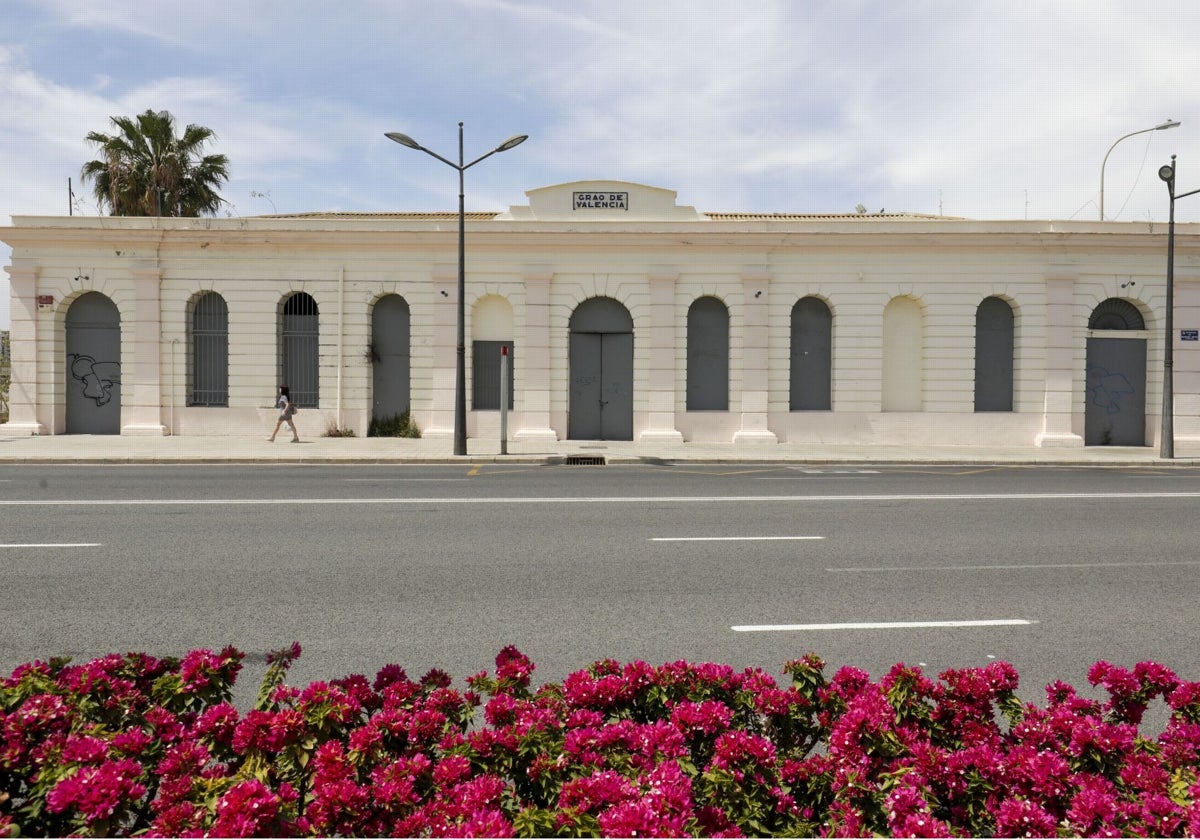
0, 644, 1200, 836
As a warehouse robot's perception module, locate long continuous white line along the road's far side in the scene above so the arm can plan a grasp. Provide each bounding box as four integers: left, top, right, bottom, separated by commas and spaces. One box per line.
0, 491, 1200, 508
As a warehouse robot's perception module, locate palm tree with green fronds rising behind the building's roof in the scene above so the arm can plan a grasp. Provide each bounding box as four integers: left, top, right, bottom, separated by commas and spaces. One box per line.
82, 110, 229, 216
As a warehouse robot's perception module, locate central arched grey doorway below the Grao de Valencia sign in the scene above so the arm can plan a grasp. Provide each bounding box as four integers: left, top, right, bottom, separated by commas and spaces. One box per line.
566, 298, 634, 440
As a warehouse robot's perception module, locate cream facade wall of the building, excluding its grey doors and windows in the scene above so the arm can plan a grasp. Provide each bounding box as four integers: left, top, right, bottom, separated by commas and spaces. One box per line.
0, 182, 1200, 446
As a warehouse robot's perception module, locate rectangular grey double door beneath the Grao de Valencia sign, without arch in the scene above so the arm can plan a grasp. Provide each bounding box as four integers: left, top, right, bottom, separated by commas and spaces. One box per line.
566, 332, 634, 440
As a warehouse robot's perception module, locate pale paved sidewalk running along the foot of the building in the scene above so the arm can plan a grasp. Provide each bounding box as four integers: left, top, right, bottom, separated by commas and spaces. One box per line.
0, 432, 1200, 467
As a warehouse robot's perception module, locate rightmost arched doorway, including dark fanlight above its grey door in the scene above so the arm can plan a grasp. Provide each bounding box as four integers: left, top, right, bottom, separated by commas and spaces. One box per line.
1084, 298, 1146, 446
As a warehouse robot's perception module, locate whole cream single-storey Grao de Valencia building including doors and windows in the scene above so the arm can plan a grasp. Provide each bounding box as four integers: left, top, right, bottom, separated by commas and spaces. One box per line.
0, 181, 1200, 446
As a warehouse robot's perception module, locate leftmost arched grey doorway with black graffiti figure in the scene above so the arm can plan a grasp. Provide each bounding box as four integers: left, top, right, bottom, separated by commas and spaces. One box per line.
66, 292, 121, 434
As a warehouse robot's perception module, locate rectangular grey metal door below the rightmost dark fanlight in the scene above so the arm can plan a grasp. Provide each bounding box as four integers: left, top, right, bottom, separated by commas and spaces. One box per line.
1084, 338, 1146, 446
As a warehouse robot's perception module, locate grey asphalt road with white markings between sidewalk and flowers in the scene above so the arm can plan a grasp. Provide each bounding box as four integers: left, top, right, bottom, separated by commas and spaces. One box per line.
0, 464, 1200, 708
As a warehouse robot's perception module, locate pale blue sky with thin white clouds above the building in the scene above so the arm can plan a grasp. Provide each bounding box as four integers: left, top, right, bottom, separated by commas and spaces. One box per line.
0, 0, 1200, 330
